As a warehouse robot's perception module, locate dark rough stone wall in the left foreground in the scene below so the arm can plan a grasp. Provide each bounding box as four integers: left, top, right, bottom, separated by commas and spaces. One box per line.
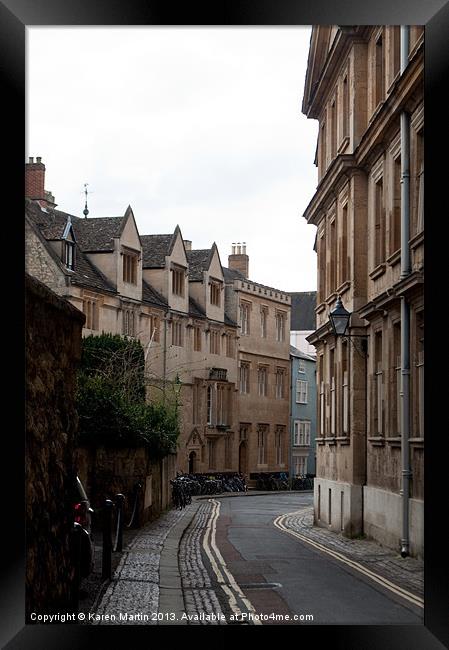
25, 275, 84, 617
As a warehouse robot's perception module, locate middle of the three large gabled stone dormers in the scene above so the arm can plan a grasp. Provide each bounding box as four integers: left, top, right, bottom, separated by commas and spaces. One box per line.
141, 226, 189, 313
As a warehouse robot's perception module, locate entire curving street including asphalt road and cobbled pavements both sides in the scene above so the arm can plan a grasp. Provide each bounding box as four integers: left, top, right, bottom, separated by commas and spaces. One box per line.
90, 492, 424, 625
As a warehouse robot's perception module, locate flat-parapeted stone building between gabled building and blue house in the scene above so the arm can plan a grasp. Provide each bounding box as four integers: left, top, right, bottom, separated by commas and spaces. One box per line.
224, 245, 291, 479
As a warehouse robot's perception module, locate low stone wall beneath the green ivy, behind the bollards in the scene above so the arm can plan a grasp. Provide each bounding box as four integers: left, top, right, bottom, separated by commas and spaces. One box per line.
76, 446, 175, 530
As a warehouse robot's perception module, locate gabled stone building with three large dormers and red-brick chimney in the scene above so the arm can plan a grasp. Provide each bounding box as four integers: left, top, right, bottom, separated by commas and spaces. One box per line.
25, 158, 237, 472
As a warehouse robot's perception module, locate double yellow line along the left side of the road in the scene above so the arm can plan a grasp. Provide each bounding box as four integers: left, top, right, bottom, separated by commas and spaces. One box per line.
203, 499, 262, 625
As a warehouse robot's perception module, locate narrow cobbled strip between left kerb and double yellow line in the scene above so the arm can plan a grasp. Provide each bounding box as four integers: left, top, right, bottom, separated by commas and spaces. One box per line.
179, 501, 226, 625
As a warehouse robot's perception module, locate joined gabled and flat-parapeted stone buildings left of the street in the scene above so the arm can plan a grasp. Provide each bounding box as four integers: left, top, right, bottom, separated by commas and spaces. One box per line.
25, 159, 290, 478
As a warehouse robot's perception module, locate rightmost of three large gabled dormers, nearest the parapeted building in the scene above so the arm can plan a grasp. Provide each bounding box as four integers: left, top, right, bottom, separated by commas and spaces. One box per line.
187, 242, 225, 322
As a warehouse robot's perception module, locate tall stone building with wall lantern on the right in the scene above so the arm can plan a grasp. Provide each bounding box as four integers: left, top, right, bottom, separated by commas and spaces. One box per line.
303, 26, 424, 556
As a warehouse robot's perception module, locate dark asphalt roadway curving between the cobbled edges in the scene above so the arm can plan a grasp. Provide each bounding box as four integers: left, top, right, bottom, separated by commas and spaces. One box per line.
180, 493, 423, 625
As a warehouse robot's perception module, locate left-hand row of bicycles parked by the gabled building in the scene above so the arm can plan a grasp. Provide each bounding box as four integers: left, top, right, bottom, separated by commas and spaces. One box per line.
170, 473, 248, 509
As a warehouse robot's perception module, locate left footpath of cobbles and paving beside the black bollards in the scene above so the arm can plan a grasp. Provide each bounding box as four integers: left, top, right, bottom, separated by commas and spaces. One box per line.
90, 510, 185, 625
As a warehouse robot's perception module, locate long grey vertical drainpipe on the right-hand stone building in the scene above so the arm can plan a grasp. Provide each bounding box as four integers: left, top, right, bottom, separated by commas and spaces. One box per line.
401, 25, 411, 557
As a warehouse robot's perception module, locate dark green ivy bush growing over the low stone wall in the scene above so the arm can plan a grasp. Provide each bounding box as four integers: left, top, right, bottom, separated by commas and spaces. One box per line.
76, 334, 179, 458
